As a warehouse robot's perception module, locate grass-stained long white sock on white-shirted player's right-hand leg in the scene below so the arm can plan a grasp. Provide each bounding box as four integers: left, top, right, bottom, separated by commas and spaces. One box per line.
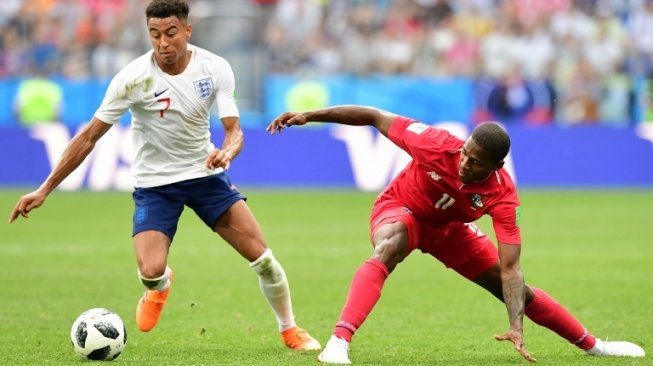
249, 249, 295, 331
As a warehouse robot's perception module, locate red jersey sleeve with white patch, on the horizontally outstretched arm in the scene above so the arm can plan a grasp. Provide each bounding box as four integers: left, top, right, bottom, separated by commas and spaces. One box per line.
388, 116, 463, 161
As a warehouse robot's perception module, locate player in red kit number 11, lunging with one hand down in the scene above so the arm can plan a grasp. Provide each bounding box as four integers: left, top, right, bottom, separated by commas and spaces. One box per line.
267, 105, 645, 364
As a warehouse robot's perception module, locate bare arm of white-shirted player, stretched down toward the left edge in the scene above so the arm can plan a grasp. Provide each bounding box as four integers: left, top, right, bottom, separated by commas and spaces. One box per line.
9, 117, 112, 223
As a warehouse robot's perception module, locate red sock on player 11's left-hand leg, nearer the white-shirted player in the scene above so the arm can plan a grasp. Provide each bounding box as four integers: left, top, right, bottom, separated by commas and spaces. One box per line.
333, 258, 389, 342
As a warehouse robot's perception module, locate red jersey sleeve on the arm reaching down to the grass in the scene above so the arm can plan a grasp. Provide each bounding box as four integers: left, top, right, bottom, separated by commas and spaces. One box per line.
488, 171, 521, 245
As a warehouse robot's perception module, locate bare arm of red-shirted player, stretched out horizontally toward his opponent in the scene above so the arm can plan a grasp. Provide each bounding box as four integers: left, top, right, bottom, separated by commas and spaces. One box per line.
266, 105, 397, 136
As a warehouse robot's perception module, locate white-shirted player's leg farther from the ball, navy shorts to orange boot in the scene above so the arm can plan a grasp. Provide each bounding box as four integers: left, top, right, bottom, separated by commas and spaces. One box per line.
187, 173, 321, 350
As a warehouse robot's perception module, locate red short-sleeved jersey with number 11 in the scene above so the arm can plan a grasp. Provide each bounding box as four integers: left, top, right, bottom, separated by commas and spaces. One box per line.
379, 117, 521, 244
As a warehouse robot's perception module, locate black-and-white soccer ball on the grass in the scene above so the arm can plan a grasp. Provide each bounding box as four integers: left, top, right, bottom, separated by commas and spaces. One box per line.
70, 308, 127, 361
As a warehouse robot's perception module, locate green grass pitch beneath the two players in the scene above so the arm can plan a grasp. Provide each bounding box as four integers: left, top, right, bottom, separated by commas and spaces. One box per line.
0, 189, 653, 365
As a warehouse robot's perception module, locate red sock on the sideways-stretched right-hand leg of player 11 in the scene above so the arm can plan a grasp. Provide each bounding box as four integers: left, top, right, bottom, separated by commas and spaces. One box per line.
524, 288, 596, 350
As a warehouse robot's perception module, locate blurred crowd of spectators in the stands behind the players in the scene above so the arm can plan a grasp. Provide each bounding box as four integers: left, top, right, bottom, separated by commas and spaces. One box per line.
0, 0, 653, 124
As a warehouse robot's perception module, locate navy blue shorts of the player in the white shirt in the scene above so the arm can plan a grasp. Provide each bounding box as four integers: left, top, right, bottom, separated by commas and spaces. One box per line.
132, 172, 246, 241
